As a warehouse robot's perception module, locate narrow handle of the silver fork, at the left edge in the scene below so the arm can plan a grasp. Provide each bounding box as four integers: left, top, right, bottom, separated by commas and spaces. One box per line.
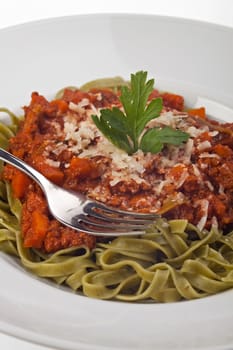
0, 148, 49, 188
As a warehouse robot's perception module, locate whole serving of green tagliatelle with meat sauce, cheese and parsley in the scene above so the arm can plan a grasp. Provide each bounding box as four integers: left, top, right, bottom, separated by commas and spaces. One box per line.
0, 72, 233, 302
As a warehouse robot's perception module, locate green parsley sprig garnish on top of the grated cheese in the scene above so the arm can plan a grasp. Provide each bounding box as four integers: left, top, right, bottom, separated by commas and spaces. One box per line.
92, 71, 189, 154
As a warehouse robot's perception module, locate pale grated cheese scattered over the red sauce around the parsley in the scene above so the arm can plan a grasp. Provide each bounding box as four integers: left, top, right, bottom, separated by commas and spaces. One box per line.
41, 94, 224, 230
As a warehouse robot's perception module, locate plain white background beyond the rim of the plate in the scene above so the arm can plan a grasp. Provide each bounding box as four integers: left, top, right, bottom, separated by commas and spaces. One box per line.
0, 0, 233, 350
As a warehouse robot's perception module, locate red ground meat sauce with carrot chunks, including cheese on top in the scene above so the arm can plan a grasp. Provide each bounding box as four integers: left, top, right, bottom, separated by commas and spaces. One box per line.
4, 89, 233, 253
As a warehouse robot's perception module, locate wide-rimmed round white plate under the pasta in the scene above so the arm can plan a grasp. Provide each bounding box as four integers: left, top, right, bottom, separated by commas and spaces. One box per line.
0, 15, 233, 350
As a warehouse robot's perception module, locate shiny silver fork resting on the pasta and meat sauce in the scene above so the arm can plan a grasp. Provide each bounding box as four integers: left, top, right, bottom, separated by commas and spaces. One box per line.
0, 148, 158, 237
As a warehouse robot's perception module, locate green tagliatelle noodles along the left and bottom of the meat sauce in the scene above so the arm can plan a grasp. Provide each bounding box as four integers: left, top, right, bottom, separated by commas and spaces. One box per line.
0, 93, 233, 302
